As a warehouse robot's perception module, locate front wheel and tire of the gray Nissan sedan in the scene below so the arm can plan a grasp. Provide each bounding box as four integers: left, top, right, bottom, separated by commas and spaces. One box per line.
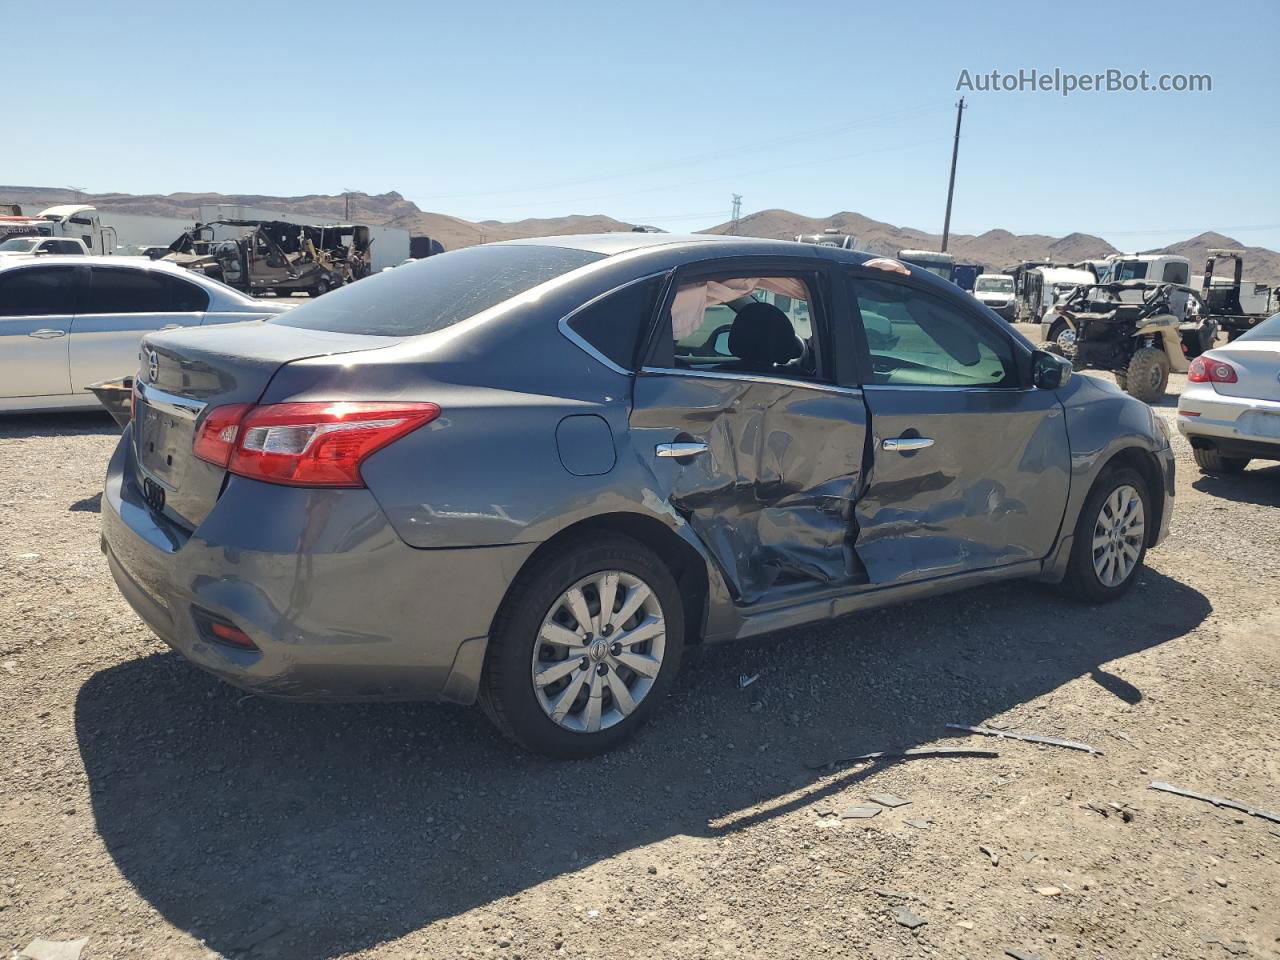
1064, 467, 1155, 603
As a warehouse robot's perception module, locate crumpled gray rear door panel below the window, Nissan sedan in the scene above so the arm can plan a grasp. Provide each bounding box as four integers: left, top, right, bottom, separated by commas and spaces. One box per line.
631, 372, 867, 603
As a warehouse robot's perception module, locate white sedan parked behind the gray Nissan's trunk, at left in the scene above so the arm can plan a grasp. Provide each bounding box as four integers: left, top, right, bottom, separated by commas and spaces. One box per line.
0, 256, 291, 413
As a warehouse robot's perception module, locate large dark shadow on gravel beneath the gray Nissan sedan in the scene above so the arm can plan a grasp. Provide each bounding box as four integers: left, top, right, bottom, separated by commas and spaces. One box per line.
76, 570, 1211, 959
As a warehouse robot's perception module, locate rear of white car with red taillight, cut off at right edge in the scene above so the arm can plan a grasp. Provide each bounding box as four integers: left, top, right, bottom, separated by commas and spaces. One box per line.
1178, 314, 1280, 474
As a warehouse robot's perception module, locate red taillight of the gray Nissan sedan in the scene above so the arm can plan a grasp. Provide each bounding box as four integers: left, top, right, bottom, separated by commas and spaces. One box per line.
195, 402, 440, 486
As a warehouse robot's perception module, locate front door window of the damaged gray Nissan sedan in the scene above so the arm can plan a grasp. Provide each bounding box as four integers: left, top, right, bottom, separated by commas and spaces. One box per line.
852, 273, 1018, 387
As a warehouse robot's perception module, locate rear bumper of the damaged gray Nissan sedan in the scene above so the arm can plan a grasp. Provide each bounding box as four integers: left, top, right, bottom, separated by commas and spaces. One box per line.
102, 430, 535, 703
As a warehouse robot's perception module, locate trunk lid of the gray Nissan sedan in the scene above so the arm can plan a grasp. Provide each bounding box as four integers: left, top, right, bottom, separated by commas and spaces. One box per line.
133, 323, 401, 529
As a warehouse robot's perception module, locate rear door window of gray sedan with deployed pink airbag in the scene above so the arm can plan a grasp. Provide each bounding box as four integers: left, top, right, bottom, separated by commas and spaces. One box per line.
669, 276, 822, 379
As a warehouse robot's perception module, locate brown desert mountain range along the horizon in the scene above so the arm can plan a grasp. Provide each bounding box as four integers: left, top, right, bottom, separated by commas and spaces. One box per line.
0, 186, 1280, 285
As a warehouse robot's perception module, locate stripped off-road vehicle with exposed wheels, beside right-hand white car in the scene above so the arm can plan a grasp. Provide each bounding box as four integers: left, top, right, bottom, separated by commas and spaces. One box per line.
1041, 280, 1219, 403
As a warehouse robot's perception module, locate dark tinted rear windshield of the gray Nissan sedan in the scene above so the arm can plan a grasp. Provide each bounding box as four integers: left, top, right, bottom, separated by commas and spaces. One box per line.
269, 244, 604, 337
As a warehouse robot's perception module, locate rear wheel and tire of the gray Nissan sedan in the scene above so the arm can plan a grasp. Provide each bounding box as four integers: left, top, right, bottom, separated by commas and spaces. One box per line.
480, 535, 685, 759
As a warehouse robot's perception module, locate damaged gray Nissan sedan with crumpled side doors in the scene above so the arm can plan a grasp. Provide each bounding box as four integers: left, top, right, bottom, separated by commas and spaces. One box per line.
102, 233, 1174, 756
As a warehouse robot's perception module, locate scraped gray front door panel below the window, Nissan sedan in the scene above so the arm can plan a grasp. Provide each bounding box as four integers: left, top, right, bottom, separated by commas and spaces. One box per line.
856, 387, 1071, 584
